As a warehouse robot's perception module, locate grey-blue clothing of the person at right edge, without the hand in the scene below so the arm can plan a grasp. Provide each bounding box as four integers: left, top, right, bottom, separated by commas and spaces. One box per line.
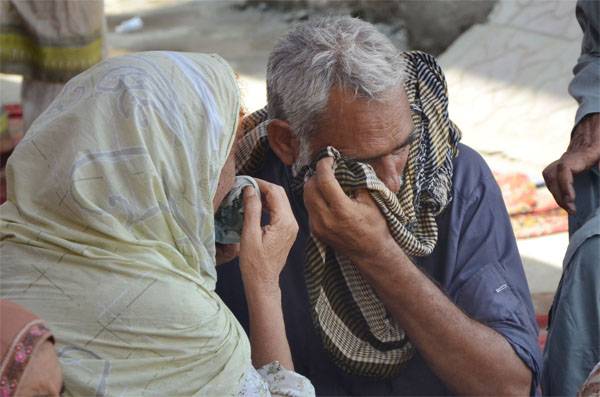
542, 0, 600, 396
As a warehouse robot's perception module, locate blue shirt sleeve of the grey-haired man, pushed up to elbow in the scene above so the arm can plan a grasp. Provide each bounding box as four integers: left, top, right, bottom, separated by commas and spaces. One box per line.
450, 171, 541, 395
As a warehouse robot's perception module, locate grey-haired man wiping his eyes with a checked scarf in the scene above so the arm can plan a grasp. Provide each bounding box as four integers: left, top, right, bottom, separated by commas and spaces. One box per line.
217, 18, 541, 395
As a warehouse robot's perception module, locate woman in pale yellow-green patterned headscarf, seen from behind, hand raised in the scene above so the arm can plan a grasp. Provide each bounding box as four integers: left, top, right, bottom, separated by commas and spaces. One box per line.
0, 52, 313, 396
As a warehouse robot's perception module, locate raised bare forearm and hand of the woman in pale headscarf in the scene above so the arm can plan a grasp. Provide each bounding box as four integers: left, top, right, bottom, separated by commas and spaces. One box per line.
240, 179, 298, 370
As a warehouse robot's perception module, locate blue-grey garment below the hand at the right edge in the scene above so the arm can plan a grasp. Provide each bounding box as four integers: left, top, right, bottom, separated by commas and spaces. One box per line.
542, 168, 600, 396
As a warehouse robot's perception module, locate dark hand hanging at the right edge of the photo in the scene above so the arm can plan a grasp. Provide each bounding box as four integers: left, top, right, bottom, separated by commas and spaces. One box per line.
543, 113, 600, 214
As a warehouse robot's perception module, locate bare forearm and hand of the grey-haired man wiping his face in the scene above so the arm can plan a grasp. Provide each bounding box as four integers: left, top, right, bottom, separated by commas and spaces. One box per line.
304, 158, 532, 395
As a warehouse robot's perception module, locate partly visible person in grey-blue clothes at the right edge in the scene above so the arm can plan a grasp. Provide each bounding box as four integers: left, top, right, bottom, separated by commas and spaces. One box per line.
542, 0, 600, 396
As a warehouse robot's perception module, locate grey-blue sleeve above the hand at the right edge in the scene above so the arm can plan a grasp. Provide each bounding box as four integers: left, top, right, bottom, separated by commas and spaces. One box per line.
569, 0, 600, 125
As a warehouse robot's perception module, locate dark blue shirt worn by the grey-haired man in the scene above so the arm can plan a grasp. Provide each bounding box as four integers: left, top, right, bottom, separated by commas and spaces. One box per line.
217, 145, 541, 395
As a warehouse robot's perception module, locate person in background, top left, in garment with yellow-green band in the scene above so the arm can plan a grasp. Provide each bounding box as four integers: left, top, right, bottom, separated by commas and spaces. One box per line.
0, 0, 106, 132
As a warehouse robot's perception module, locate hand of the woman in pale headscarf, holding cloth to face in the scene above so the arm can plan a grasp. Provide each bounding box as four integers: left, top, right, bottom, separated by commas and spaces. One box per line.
240, 179, 298, 294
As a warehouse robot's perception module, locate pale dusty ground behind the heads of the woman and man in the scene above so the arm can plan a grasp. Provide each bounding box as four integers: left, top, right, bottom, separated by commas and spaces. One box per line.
105, 0, 406, 110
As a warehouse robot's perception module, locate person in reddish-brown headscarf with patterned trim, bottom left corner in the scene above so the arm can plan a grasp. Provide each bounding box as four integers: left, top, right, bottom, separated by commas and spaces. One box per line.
0, 300, 62, 397
